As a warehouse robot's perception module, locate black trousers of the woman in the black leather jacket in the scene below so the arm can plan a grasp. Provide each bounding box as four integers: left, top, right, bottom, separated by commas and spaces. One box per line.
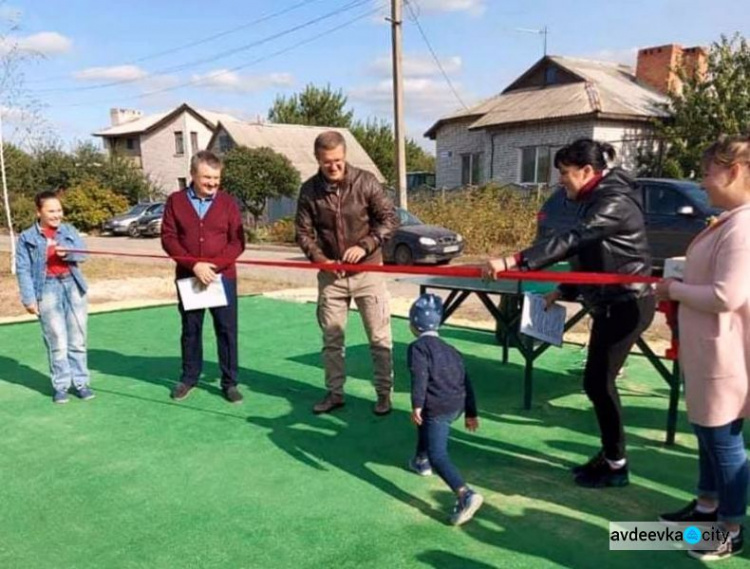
583, 296, 656, 460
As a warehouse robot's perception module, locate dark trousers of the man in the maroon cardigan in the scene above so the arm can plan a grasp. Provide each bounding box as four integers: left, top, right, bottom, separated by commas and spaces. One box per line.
179, 278, 239, 389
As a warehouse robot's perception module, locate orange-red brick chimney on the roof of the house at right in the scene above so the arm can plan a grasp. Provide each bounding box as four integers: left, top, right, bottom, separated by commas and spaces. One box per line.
635, 44, 708, 95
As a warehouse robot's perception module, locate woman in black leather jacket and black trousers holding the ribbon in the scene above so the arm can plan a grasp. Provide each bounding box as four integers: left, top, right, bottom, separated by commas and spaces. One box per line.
484, 139, 655, 488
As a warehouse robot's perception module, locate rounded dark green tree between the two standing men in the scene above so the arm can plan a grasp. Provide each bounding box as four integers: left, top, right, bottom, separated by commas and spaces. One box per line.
221, 146, 301, 226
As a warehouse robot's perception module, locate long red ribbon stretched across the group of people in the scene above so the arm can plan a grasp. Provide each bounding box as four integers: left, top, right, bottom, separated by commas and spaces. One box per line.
69, 249, 661, 285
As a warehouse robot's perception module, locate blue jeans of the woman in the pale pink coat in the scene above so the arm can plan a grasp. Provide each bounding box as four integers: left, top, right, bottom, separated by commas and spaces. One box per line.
693, 419, 748, 523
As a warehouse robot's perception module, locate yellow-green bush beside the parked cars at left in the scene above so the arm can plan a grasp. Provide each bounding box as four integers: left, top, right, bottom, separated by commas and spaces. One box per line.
62, 180, 128, 231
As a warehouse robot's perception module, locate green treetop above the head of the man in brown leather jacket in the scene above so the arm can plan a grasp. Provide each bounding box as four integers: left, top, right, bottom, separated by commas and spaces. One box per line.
268, 84, 354, 128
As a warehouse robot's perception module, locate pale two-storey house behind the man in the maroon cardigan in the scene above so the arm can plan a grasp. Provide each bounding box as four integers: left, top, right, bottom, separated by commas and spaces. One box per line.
94, 104, 237, 195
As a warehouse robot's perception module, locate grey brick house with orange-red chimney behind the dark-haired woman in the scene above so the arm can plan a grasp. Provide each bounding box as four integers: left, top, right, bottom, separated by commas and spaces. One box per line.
425, 44, 706, 188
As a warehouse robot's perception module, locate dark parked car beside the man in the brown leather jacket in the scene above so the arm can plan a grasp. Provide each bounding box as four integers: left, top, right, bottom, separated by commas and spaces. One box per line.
383, 208, 464, 265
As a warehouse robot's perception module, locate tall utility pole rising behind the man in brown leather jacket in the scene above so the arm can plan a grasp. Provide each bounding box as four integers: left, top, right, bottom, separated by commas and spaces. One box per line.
391, 0, 408, 209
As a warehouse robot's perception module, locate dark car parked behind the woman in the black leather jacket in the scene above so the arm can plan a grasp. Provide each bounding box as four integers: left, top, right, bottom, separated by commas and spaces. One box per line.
537, 178, 721, 270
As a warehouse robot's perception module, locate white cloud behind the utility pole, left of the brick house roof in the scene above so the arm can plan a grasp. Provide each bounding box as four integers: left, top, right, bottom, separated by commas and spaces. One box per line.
348, 78, 473, 121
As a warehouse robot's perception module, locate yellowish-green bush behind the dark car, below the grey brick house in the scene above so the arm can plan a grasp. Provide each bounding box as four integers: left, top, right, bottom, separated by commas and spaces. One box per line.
410, 184, 543, 255
